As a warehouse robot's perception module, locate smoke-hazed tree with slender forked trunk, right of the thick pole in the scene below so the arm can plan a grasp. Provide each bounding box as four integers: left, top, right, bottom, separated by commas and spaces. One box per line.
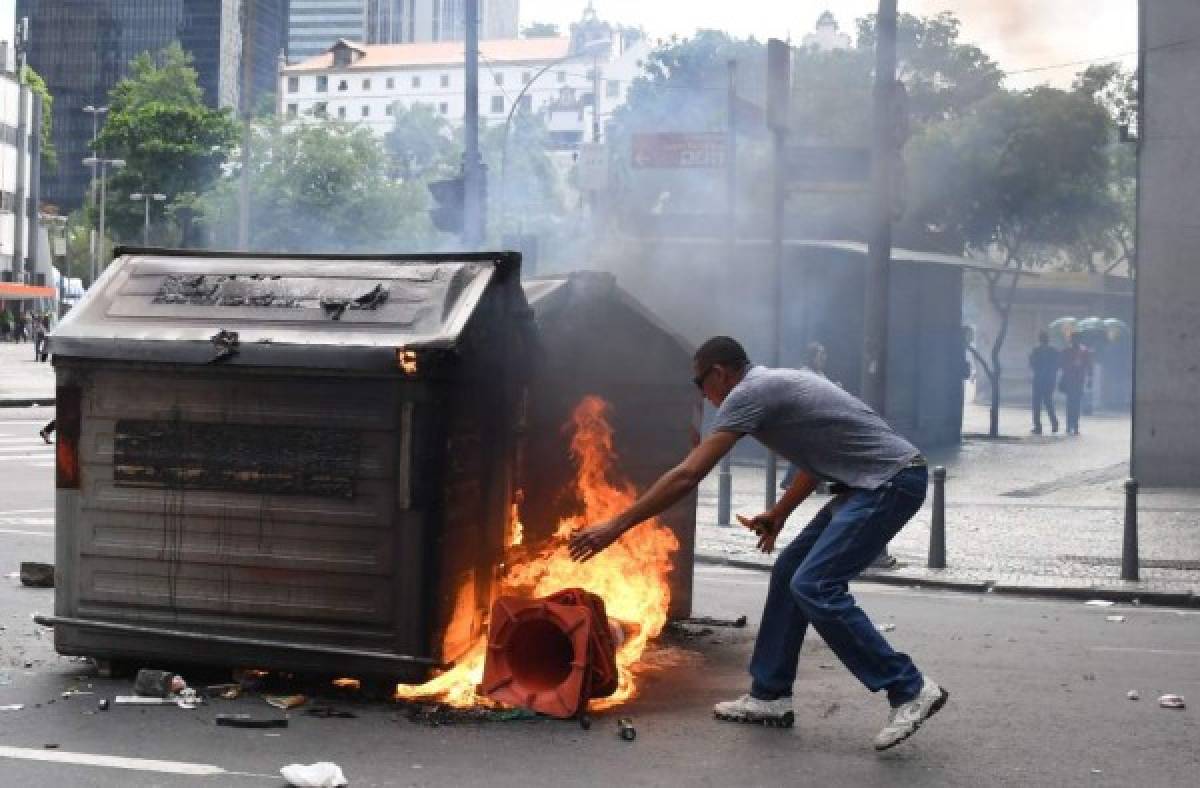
910, 88, 1110, 435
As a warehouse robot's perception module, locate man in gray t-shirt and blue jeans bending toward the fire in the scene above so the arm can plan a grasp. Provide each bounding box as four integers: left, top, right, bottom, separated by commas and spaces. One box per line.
571, 337, 948, 750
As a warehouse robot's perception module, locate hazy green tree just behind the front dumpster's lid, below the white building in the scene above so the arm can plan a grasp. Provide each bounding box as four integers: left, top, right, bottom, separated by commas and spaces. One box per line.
197, 122, 432, 252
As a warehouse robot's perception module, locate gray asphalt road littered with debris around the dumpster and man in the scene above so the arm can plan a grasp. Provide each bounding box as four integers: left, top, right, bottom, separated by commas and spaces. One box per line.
0, 411, 1200, 788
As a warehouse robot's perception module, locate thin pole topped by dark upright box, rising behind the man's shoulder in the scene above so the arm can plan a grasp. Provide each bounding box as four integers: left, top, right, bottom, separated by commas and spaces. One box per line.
764, 38, 792, 509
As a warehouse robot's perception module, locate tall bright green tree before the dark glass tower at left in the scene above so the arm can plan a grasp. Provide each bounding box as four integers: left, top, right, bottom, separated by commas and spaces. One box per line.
96, 44, 239, 242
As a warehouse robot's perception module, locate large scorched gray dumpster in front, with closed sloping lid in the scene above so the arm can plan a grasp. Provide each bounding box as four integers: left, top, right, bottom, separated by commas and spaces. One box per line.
41, 249, 532, 681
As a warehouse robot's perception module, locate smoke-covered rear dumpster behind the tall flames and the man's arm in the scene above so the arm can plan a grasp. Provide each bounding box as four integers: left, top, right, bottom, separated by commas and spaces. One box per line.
521, 271, 701, 618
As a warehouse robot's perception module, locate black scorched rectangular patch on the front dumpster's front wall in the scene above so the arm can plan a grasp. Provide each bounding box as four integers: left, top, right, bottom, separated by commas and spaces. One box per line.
113, 421, 359, 498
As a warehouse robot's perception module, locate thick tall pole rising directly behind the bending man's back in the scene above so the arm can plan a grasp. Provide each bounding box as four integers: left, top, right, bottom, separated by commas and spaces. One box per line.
862, 0, 896, 415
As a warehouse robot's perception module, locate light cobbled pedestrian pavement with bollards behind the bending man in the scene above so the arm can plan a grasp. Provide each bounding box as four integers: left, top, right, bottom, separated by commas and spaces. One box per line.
697, 405, 1200, 604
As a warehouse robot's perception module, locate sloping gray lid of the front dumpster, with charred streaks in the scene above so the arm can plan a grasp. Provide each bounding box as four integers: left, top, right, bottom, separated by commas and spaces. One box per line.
50, 247, 520, 368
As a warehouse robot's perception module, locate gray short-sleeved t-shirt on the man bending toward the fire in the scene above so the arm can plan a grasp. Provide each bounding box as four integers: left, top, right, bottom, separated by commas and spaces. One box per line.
713, 367, 920, 489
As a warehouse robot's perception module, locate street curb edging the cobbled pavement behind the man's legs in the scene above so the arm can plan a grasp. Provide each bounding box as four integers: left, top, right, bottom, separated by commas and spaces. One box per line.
695, 553, 1200, 607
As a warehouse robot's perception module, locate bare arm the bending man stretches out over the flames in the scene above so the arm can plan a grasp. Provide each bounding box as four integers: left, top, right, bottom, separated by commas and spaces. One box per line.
571, 432, 742, 561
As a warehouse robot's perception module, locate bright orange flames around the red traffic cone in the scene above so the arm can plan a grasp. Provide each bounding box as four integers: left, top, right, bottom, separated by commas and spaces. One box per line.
396, 397, 679, 708
